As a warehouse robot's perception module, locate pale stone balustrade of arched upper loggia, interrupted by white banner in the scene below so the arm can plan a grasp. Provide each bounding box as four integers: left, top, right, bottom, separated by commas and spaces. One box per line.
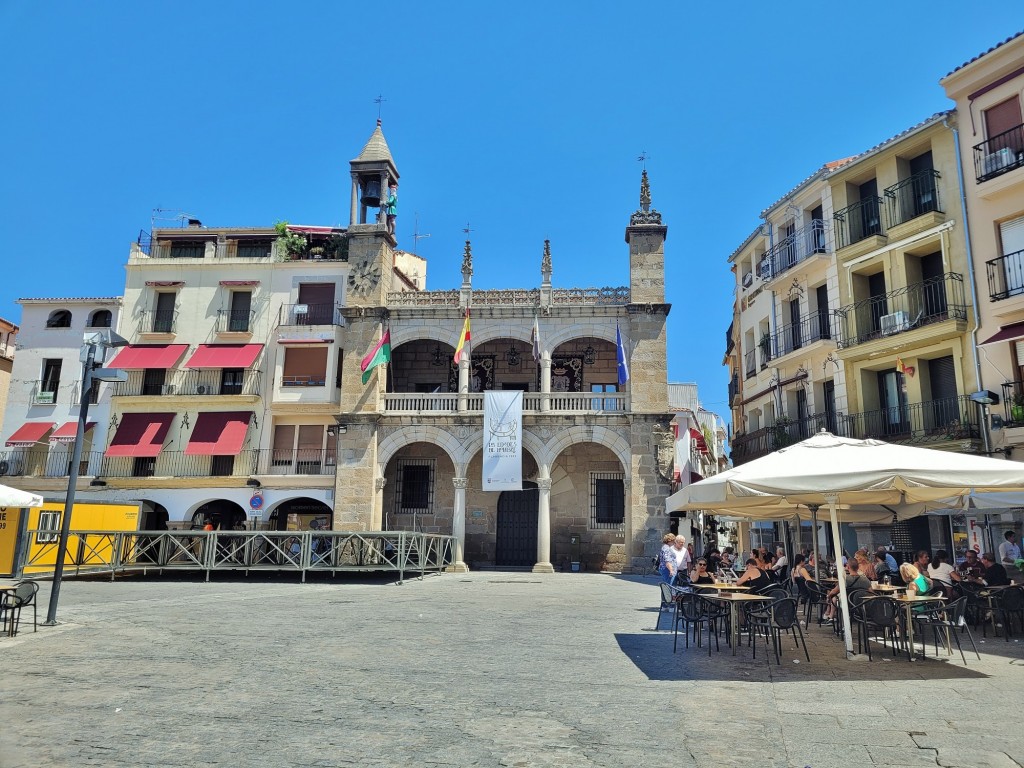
384, 392, 628, 415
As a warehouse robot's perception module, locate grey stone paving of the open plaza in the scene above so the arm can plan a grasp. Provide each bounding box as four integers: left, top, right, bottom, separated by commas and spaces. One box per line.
0, 571, 1024, 768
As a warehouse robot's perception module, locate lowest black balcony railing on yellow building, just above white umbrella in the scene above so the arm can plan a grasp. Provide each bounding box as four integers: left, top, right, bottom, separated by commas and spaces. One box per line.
843, 395, 981, 442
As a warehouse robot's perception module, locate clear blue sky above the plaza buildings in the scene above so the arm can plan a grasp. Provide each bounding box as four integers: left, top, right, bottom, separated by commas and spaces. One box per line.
0, 0, 1024, 416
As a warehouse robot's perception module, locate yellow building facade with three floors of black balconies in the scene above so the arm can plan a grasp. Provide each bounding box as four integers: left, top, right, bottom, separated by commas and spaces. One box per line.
828, 112, 983, 452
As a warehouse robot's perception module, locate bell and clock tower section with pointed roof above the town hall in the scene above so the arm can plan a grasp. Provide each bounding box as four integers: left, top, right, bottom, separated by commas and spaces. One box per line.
345, 120, 398, 306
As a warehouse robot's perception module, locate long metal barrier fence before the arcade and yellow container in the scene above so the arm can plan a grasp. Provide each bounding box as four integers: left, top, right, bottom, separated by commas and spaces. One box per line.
22, 529, 455, 584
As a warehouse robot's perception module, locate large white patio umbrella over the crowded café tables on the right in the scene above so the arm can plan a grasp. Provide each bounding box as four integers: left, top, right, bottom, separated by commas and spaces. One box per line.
666, 431, 1024, 653
